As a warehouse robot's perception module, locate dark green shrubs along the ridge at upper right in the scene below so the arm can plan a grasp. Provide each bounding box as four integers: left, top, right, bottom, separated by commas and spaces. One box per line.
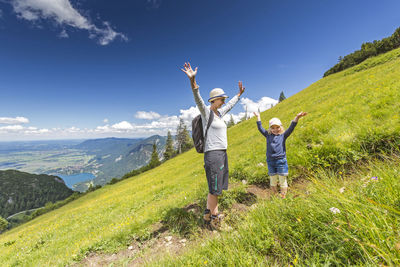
324, 28, 400, 77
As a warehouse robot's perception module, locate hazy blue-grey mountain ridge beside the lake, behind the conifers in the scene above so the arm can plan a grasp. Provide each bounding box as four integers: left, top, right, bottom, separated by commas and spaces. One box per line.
74, 135, 167, 191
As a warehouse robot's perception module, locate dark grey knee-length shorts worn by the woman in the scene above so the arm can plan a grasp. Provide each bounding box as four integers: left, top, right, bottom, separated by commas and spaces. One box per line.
204, 150, 229, 196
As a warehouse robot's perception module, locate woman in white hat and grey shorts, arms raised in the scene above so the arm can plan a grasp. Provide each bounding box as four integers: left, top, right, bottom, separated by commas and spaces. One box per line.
182, 63, 245, 228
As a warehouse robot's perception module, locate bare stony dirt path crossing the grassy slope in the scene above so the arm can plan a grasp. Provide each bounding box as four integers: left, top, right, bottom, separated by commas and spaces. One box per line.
72, 180, 308, 266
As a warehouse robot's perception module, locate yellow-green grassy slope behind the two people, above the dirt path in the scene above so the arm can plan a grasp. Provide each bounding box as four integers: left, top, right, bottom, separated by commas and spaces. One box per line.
0, 47, 400, 266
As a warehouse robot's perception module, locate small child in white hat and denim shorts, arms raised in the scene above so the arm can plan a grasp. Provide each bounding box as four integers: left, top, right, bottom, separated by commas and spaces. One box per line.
254, 112, 307, 198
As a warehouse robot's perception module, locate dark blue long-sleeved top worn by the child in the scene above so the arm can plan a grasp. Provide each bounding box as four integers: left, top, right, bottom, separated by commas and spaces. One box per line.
257, 121, 297, 160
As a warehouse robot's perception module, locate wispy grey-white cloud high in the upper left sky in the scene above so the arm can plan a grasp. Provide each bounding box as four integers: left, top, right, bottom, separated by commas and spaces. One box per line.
11, 0, 128, 45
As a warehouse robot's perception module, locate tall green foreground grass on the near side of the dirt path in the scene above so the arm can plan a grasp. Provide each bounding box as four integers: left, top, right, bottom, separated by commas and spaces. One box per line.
155, 158, 400, 266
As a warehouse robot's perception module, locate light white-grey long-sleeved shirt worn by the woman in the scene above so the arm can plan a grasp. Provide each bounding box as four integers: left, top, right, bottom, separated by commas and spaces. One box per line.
193, 87, 240, 152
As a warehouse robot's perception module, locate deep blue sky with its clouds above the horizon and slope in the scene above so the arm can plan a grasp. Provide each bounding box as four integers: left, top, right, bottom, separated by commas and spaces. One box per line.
0, 0, 400, 141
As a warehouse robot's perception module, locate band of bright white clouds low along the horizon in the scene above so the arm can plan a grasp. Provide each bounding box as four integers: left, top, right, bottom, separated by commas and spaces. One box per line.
0, 97, 278, 140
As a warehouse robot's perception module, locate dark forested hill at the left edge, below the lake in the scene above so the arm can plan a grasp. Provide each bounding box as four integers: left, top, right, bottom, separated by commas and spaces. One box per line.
0, 170, 73, 218
